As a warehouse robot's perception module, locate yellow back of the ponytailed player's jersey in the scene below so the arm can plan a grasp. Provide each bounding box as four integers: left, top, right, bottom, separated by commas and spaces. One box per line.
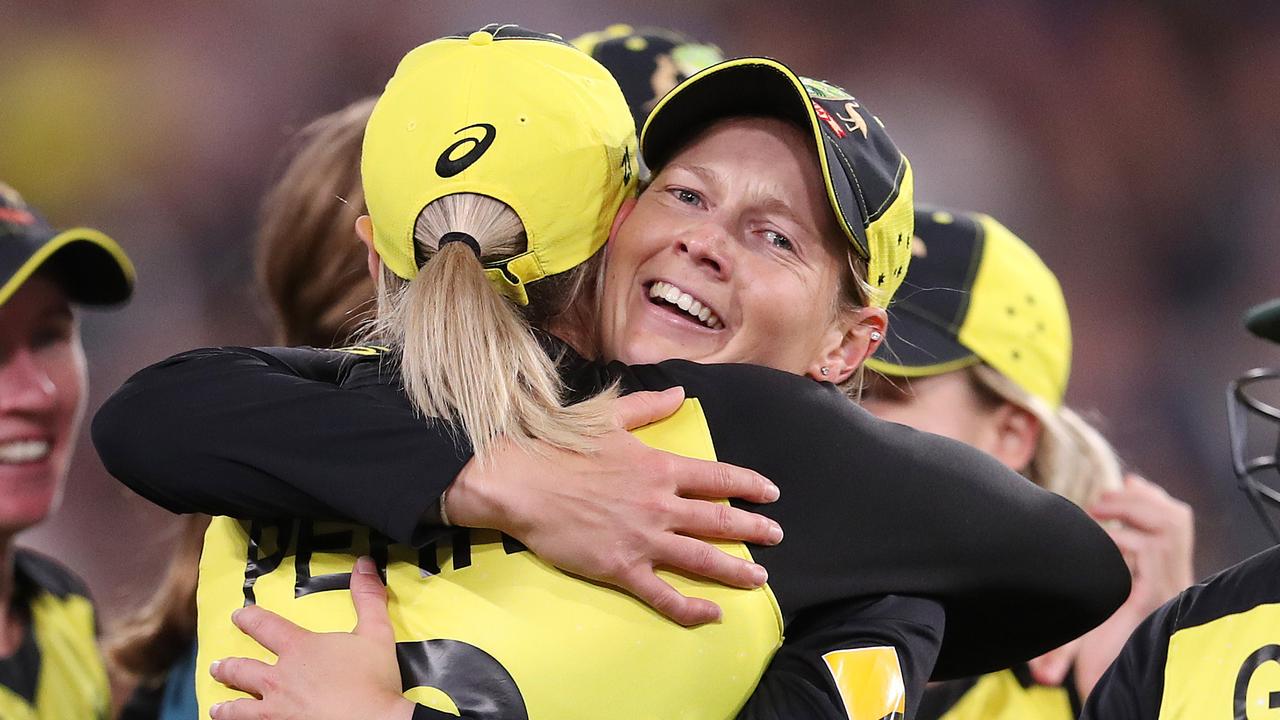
197, 400, 782, 720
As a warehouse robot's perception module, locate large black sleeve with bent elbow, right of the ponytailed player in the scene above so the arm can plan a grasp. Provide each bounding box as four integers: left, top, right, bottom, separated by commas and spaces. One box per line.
619, 360, 1130, 680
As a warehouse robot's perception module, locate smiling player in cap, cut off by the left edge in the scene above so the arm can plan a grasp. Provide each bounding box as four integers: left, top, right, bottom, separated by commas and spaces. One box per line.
0, 183, 133, 720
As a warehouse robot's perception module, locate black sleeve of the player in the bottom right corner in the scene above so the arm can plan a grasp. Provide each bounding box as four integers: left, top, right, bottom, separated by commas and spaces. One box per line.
1080, 596, 1184, 720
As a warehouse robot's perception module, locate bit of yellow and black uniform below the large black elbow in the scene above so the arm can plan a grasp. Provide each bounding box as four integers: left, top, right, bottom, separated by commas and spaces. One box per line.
915, 664, 1082, 720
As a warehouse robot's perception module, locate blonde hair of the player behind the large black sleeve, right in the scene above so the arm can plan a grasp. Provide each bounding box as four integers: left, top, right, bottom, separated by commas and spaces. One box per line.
966, 364, 1124, 507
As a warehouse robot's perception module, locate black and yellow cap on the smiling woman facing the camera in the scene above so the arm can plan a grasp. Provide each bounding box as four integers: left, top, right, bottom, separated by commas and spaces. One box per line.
640, 58, 914, 307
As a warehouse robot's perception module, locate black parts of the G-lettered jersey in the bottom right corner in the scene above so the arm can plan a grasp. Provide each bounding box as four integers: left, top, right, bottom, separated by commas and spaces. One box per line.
1080, 546, 1280, 720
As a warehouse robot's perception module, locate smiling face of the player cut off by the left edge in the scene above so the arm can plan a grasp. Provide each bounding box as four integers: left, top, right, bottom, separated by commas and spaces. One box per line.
0, 274, 86, 538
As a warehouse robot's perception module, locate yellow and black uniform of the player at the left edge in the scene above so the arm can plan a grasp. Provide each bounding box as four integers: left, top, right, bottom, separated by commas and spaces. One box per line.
0, 550, 110, 720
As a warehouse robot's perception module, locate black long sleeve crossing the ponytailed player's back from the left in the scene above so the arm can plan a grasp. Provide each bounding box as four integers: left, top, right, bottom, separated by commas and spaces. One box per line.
92, 347, 471, 544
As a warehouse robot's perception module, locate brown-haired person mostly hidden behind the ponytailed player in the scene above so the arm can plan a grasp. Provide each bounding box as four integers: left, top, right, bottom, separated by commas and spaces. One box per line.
106, 97, 375, 720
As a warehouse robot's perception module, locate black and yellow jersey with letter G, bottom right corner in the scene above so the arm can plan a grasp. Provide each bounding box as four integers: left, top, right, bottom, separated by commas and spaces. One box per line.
1083, 547, 1280, 720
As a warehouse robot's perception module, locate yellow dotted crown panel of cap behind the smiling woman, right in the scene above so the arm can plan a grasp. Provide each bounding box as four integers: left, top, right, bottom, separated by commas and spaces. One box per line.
957, 215, 1071, 407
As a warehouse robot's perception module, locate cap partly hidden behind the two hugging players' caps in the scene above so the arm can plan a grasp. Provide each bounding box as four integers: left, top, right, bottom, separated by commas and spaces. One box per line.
573, 24, 724, 131
